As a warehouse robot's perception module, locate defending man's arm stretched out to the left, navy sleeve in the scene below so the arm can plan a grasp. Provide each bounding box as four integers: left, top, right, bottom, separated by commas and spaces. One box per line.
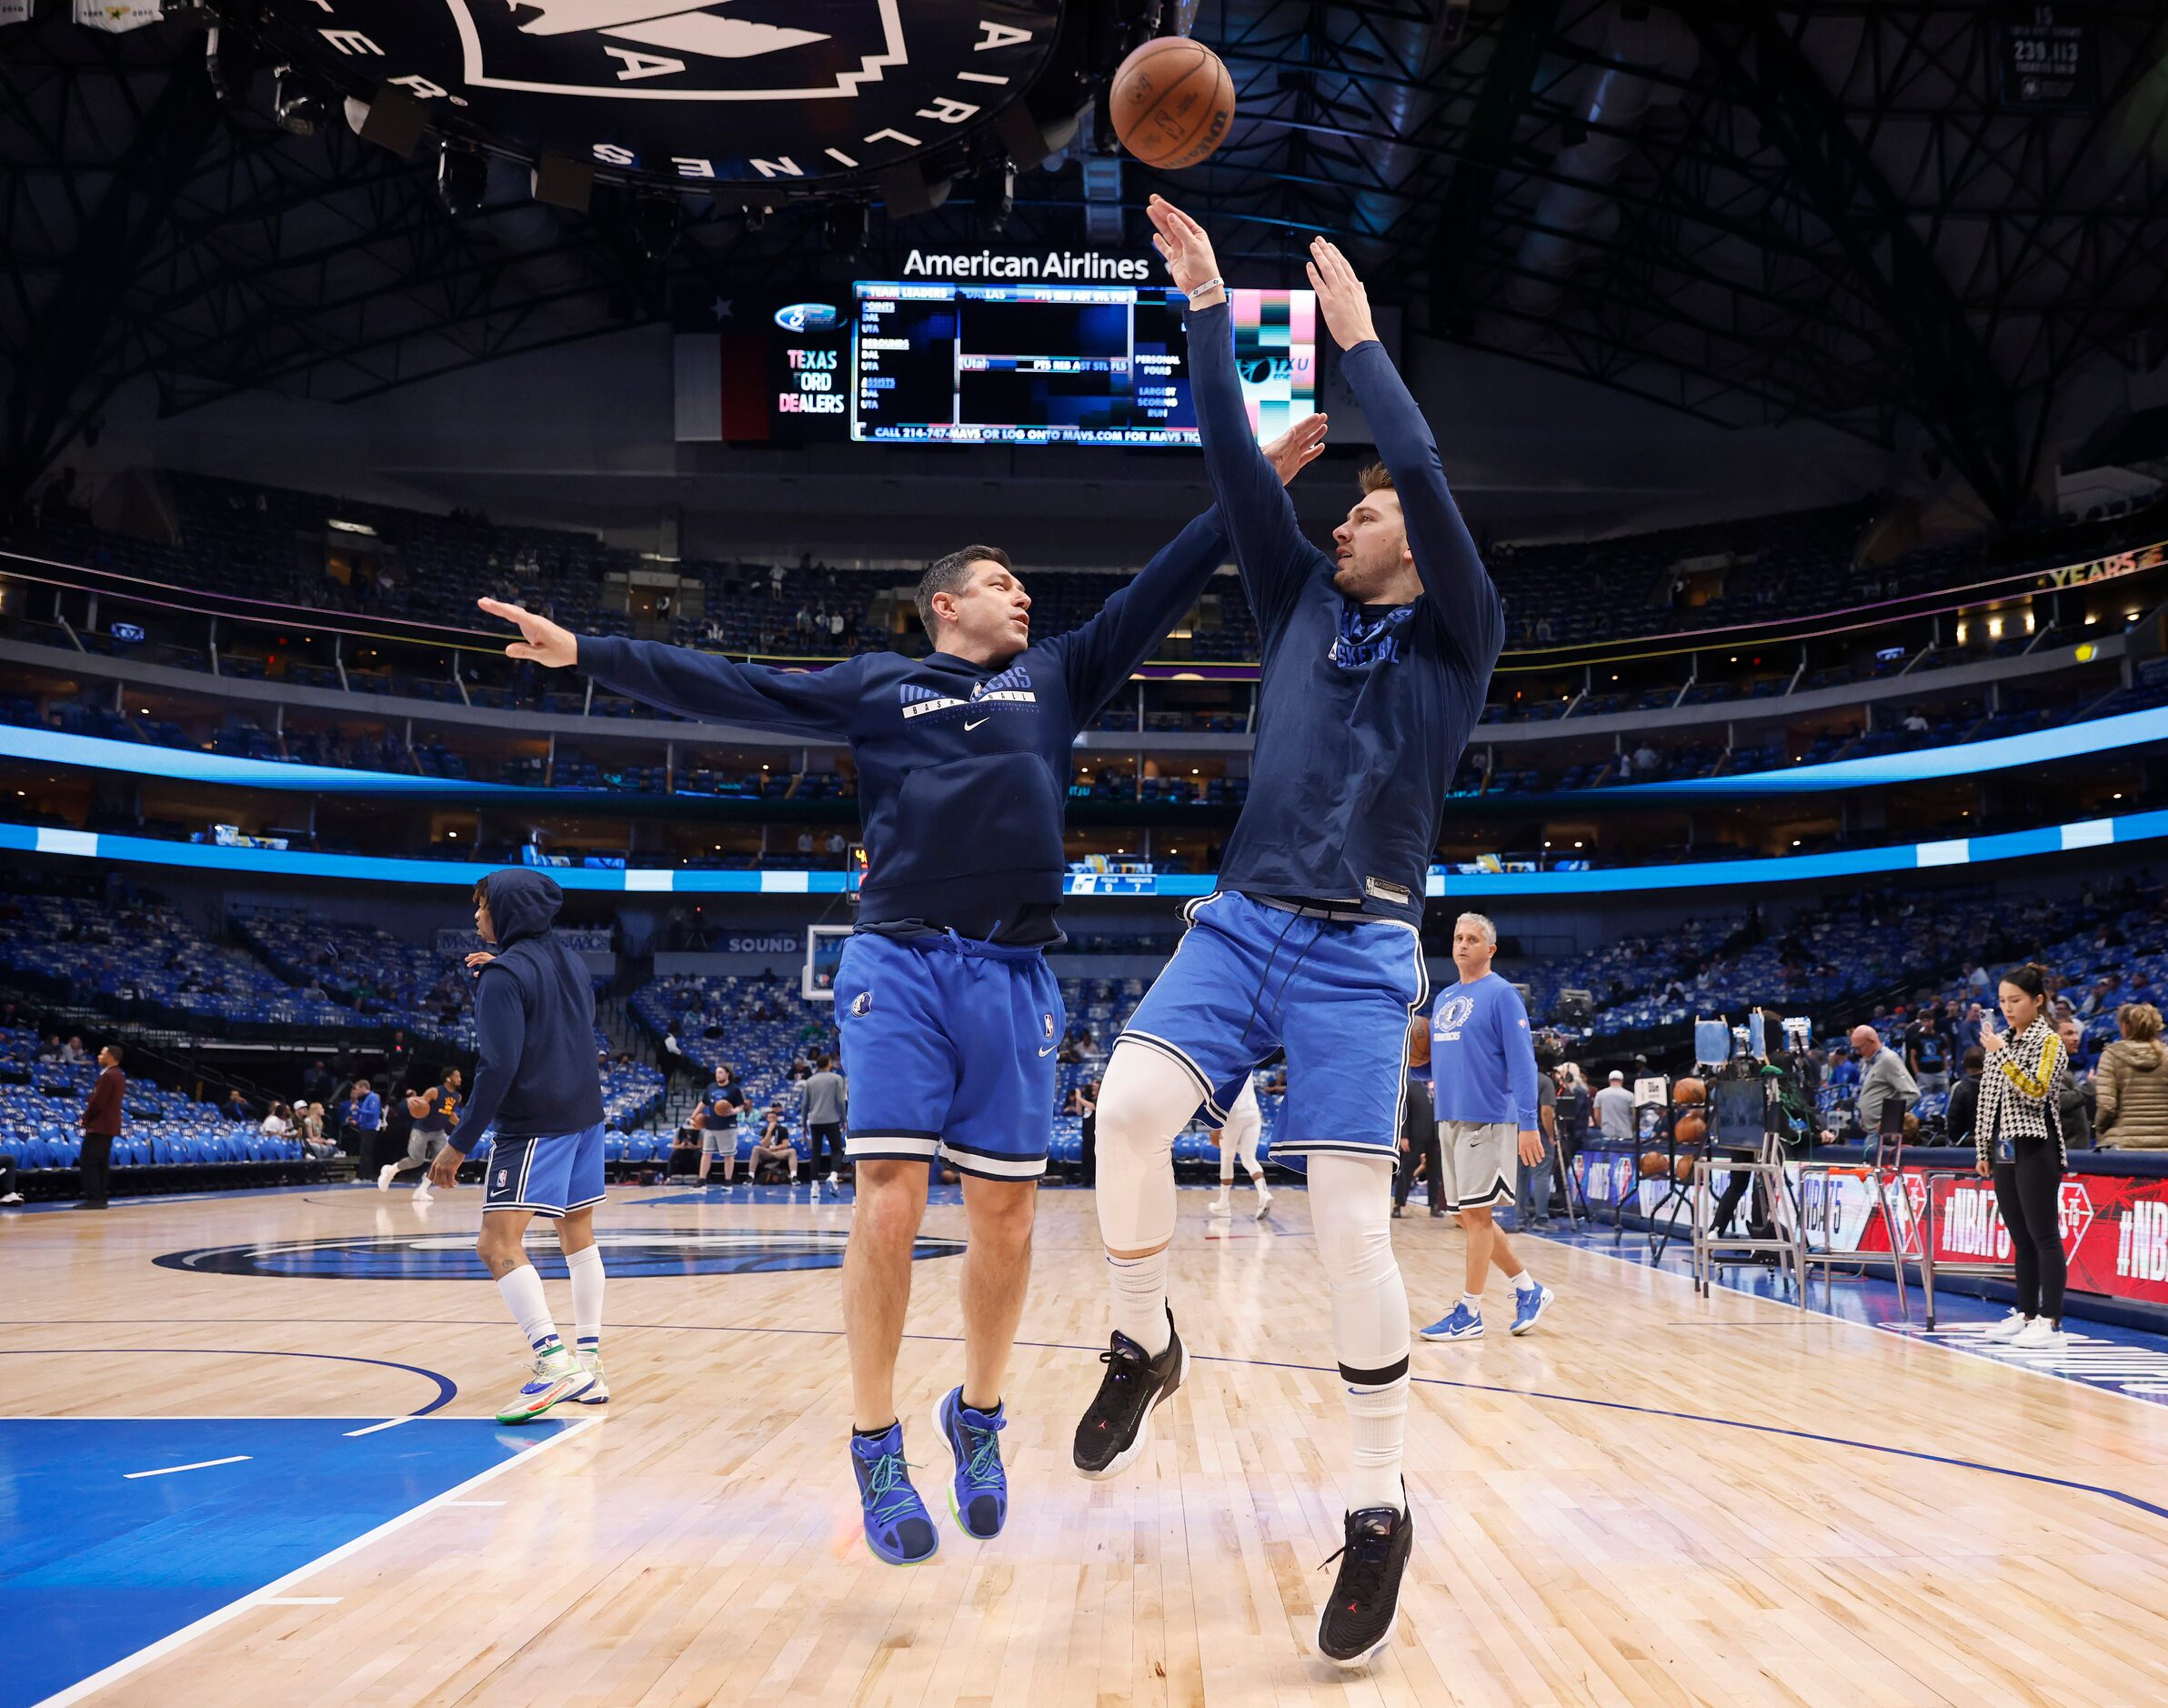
475, 598, 865, 739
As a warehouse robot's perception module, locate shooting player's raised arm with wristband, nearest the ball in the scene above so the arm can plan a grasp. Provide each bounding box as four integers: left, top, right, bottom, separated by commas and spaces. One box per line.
1145, 195, 1322, 620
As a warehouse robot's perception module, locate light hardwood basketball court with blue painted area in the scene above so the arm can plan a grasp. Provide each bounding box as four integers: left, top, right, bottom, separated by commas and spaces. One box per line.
0, 1188, 2168, 1708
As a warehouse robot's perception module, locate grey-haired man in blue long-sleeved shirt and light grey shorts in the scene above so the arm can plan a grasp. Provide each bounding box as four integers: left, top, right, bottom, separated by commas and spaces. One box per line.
1422, 912, 1552, 1340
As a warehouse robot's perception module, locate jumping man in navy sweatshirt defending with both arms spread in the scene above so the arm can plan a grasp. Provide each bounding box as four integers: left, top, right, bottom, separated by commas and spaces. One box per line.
479, 418, 1325, 1565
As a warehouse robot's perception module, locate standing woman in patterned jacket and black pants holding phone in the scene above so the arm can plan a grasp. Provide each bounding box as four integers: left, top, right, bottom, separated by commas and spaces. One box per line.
1972, 960, 2071, 1351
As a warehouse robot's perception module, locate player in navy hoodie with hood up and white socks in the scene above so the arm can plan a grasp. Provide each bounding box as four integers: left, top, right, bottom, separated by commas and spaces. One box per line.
429, 867, 609, 1424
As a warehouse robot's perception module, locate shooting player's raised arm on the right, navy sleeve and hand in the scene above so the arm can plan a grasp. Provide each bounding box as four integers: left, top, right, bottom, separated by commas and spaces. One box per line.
1310, 236, 1504, 672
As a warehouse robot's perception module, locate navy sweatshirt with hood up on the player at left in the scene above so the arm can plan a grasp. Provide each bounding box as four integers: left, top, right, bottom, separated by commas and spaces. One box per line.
451, 867, 603, 1153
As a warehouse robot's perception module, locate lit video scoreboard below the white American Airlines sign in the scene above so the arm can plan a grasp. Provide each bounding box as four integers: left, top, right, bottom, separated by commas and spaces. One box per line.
677, 279, 1318, 447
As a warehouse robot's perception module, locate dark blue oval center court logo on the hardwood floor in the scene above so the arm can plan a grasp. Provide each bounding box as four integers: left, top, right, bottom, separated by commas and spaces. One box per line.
152, 1222, 962, 1281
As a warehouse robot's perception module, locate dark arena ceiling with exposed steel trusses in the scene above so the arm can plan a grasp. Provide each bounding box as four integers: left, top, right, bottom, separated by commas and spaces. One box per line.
0, 0, 2168, 514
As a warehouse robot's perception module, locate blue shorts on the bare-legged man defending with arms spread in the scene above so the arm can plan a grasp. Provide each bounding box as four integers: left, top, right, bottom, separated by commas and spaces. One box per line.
835, 932, 1067, 1179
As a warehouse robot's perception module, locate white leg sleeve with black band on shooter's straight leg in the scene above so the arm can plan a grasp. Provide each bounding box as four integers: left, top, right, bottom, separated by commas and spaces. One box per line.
1310, 1153, 1410, 1513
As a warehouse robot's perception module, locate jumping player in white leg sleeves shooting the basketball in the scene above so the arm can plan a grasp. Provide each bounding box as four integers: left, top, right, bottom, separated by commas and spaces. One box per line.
1075, 197, 1504, 1667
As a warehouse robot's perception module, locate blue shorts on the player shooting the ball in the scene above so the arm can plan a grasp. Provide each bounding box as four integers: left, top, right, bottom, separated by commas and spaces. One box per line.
1119, 891, 1430, 1158
